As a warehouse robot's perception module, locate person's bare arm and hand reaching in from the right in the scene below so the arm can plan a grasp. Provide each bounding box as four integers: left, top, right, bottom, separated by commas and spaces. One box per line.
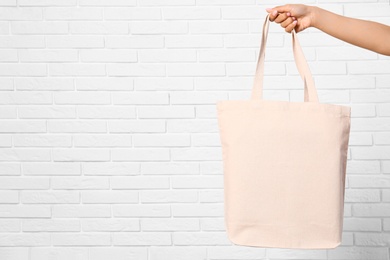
267, 5, 390, 56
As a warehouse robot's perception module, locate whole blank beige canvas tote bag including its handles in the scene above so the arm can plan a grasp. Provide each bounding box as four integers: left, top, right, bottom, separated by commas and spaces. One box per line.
217, 16, 351, 249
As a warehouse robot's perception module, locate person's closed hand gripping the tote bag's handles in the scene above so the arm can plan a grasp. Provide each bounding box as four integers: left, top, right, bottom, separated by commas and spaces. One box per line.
266, 4, 314, 33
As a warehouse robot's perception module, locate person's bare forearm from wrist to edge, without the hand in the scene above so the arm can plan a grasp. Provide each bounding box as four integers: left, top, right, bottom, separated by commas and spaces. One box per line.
312, 6, 390, 55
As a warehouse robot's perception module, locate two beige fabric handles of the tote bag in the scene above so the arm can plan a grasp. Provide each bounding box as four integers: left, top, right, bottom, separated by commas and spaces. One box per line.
251, 14, 319, 103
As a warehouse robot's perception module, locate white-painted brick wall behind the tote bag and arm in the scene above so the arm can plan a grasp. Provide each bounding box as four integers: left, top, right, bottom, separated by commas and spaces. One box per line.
0, 0, 390, 260
